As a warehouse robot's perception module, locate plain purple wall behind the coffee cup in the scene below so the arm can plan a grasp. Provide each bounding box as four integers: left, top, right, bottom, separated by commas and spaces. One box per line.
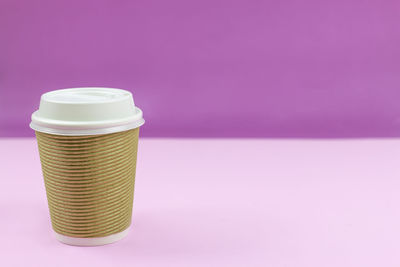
0, 0, 400, 137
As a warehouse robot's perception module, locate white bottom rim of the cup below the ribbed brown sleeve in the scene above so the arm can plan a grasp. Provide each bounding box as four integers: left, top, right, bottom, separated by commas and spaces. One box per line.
54, 227, 129, 247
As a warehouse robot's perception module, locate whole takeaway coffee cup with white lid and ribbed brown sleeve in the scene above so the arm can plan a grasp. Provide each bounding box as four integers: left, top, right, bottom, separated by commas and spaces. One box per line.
30, 88, 144, 246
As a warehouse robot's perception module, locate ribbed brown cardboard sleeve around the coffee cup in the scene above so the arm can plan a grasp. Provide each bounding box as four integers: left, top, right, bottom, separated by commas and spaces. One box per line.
36, 128, 139, 238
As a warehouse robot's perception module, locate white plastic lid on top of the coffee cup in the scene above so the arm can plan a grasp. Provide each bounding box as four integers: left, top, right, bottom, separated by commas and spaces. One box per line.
30, 87, 144, 135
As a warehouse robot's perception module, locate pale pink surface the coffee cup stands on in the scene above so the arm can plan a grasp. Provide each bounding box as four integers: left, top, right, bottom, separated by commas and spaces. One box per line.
0, 139, 400, 267
